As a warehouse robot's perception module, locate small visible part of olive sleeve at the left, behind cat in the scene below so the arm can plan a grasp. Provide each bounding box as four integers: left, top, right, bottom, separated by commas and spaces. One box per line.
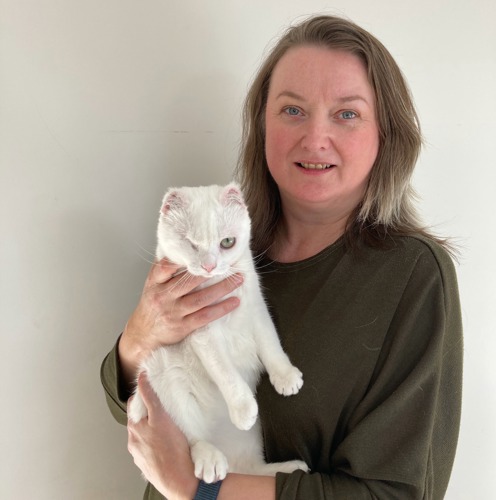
100, 337, 130, 425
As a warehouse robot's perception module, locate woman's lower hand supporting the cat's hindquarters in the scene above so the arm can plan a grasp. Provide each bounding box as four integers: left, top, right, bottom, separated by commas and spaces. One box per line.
127, 373, 198, 500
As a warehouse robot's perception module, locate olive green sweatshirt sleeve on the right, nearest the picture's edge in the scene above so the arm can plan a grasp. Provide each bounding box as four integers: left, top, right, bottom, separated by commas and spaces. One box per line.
276, 241, 463, 500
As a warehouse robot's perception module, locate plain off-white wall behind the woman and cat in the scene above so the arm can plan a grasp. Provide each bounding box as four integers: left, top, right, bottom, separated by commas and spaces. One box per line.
0, 0, 496, 500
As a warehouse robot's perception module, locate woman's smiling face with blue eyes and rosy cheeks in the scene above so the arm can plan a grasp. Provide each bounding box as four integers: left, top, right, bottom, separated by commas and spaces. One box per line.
265, 46, 379, 217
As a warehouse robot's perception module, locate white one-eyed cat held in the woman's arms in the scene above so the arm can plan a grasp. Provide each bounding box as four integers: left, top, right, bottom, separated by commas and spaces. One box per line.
129, 184, 308, 483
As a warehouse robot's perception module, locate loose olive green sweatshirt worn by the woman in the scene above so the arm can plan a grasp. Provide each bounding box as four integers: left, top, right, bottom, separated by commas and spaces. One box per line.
102, 237, 463, 500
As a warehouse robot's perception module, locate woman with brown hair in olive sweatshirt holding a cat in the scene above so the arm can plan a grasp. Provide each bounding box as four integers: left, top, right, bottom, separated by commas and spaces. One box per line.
102, 16, 462, 499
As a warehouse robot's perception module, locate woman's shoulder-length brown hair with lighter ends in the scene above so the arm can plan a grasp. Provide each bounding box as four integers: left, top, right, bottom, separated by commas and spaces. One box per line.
237, 16, 450, 253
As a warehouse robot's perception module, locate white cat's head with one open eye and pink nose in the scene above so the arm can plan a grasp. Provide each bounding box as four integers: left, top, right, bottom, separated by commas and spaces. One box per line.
157, 183, 250, 277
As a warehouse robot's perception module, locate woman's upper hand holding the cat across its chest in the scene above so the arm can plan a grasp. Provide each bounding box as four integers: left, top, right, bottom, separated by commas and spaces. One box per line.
119, 259, 242, 385
